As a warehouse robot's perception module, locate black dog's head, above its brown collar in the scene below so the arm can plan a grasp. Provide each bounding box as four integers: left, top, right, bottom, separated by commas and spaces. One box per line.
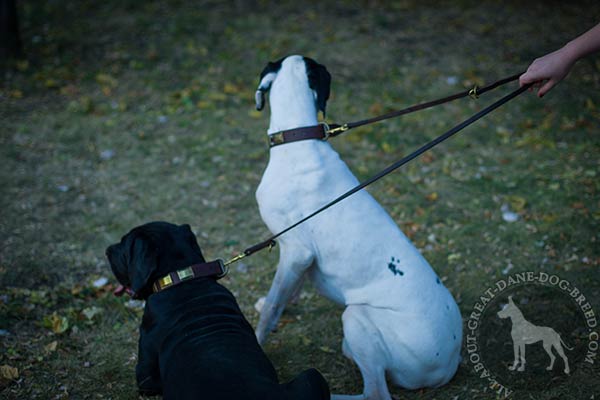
106, 222, 205, 299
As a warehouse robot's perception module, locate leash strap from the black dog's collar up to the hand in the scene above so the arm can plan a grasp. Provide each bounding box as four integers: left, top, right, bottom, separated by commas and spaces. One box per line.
225, 83, 533, 265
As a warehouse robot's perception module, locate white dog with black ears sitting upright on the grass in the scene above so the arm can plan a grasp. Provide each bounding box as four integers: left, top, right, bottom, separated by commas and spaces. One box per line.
256, 56, 462, 399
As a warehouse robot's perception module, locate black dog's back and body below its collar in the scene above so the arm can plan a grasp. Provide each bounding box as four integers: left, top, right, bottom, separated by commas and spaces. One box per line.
140, 279, 329, 400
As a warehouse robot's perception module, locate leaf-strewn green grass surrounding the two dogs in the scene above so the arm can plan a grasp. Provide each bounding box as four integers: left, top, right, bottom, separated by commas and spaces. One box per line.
0, 0, 600, 399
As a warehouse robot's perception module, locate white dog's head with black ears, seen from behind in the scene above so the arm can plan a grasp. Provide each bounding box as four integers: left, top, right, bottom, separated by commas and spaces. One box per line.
255, 56, 331, 115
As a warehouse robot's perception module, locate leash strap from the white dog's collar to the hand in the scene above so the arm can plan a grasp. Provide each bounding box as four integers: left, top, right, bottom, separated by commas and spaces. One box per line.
329, 73, 523, 137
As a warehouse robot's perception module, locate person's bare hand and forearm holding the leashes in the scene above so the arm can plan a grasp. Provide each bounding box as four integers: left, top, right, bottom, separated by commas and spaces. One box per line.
519, 24, 600, 97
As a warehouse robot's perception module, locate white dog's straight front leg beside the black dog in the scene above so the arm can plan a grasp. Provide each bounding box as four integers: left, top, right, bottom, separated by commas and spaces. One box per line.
256, 244, 313, 344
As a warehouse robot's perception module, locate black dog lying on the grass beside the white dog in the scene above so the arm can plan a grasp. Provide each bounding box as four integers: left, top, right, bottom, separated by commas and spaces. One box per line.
106, 222, 330, 400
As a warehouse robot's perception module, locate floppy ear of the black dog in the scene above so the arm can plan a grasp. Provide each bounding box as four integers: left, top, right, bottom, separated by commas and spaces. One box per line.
129, 235, 157, 298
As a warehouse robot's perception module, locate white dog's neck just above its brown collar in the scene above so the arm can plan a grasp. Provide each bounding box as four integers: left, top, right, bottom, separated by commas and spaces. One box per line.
267, 74, 318, 134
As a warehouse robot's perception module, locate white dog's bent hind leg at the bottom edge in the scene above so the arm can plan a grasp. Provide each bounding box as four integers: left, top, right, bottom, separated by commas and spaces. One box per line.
331, 306, 392, 400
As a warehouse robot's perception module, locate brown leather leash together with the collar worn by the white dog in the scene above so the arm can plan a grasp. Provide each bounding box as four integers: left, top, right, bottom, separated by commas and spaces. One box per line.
269, 72, 523, 147
